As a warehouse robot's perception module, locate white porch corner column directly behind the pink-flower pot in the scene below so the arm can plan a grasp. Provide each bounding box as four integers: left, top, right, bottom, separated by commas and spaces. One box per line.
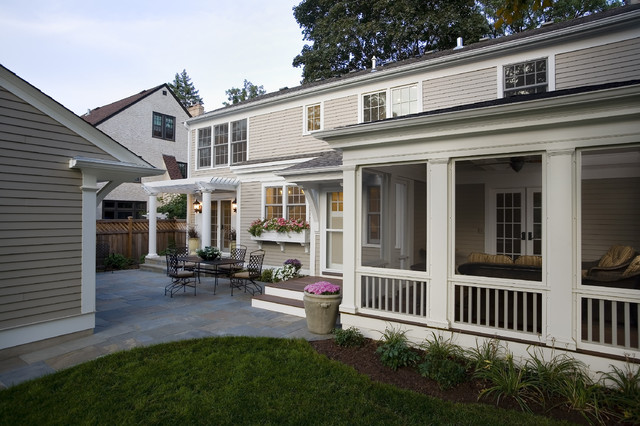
340, 166, 360, 314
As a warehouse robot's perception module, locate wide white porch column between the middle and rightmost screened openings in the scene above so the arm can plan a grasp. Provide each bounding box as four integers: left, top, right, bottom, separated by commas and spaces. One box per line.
542, 149, 576, 349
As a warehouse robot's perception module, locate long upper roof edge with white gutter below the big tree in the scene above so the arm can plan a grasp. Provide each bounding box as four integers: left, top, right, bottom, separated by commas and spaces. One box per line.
188, 4, 640, 123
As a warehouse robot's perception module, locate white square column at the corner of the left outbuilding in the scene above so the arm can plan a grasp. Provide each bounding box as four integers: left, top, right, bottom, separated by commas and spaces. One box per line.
80, 173, 98, 316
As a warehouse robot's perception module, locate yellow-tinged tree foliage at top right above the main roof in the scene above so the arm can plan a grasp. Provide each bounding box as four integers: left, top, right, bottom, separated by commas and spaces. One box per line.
481, 0, 623, 35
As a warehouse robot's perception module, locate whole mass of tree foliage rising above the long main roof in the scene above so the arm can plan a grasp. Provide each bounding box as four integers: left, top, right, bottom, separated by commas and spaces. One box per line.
293, 0, 621, 83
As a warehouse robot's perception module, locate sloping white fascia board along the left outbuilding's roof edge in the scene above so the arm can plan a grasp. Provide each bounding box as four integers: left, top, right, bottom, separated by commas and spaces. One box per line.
0, 66, 153, 167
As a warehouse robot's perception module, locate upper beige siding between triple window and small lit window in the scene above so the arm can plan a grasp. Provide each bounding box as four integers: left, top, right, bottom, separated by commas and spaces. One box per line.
249, 107, 329, 161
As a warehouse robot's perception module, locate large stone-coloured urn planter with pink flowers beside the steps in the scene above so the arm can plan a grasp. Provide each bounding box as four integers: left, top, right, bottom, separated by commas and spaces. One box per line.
303, 281, 342, 334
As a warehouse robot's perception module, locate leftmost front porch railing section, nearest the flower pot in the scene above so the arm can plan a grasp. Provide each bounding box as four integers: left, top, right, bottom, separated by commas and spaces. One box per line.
360, 275, 427, 318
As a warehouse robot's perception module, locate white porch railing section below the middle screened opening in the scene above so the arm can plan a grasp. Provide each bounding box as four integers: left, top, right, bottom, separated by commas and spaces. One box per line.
453, 283, 543, 334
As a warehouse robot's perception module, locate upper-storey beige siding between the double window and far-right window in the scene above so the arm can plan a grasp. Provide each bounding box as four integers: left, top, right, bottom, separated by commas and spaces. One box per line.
422, 67, 497, 111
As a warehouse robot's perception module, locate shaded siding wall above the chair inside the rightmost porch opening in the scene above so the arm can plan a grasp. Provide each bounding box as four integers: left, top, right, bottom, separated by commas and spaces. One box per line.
582, 178, 640, 261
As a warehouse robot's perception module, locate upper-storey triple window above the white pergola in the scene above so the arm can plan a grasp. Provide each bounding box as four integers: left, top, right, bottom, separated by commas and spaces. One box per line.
198, 119, 247, 168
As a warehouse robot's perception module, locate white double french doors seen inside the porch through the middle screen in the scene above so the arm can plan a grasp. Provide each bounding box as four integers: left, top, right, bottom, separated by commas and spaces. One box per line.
494, 188, 542, 259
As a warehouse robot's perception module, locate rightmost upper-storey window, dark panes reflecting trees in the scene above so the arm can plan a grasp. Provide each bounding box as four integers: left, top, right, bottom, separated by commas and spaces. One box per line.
504, 58, 547, 98
